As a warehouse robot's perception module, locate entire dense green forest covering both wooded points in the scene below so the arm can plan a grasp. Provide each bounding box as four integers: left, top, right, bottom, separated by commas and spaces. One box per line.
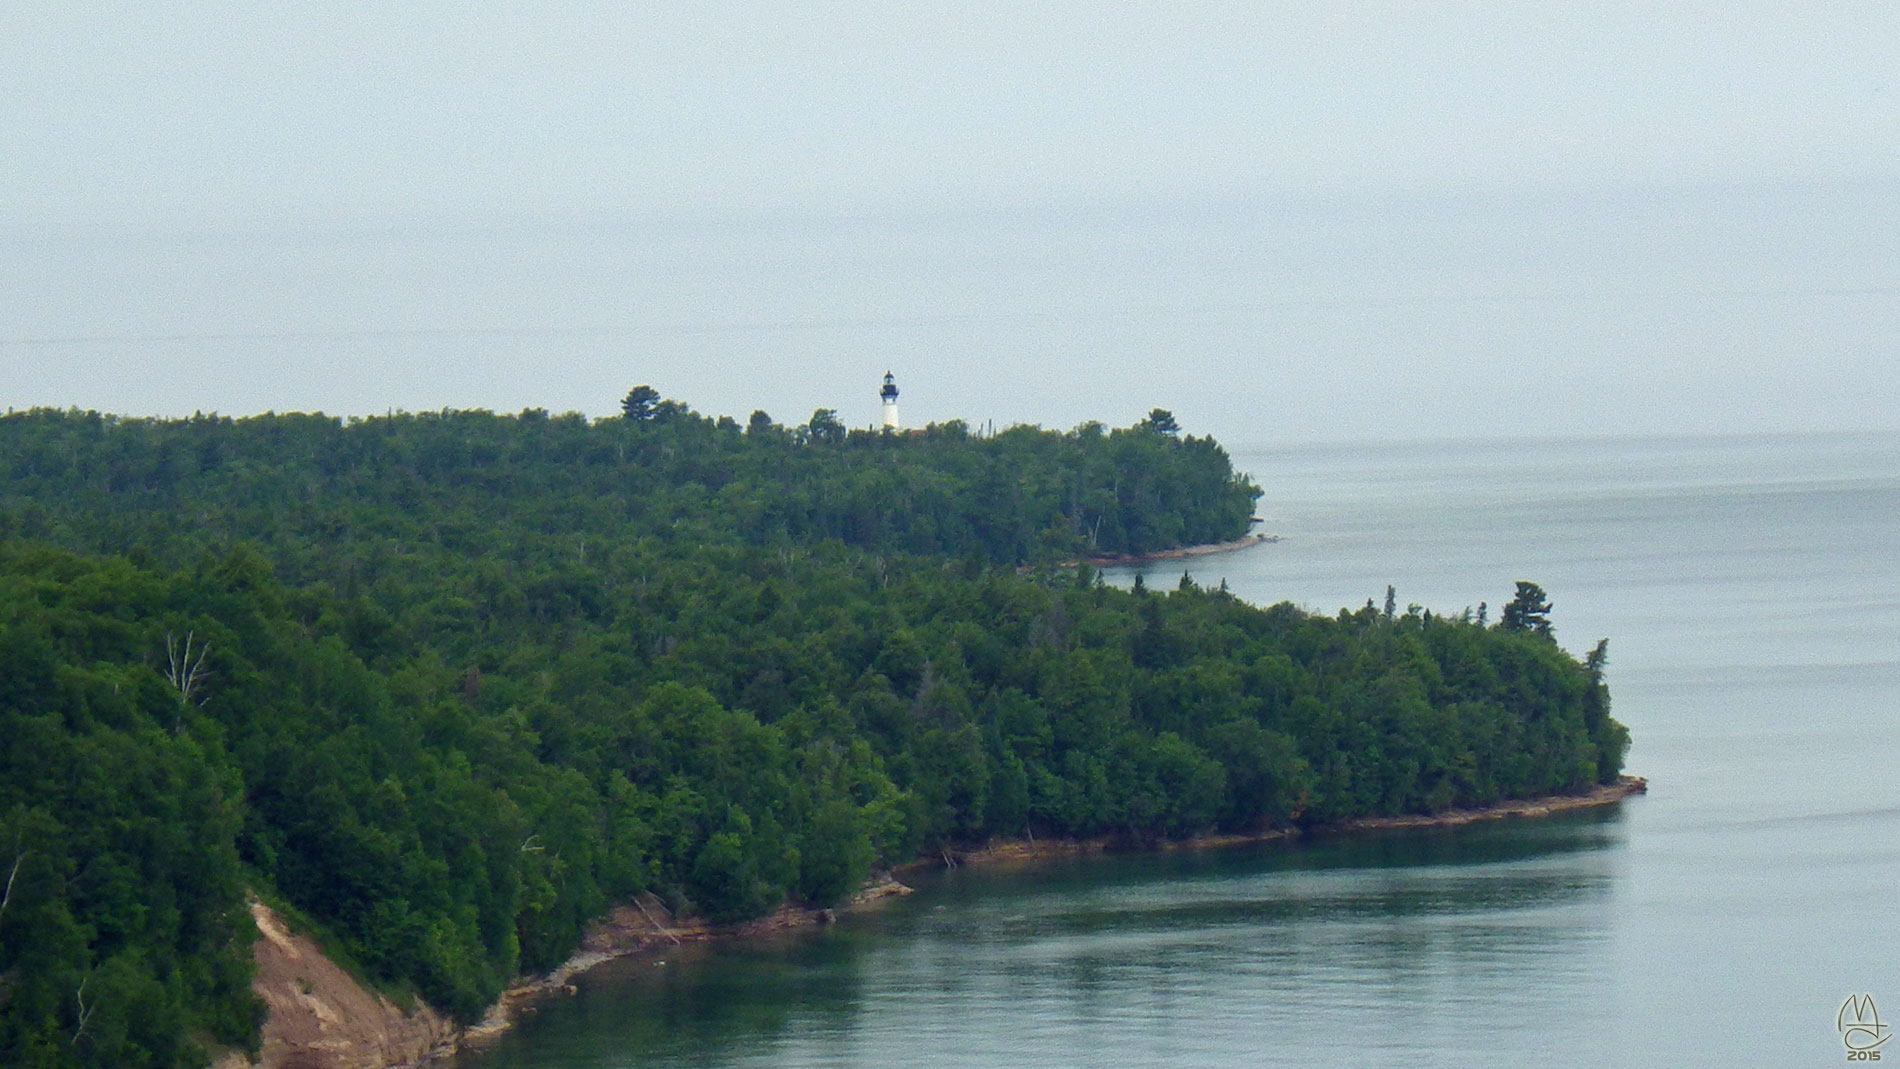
0, 402, 1628, 1067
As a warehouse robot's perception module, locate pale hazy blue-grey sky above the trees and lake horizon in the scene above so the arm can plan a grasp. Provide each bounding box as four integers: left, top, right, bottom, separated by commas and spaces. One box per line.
0, 0, 1900, 442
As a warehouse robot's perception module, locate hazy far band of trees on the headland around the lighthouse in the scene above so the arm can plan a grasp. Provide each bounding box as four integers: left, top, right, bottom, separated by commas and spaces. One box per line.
0, 401, 1260, 569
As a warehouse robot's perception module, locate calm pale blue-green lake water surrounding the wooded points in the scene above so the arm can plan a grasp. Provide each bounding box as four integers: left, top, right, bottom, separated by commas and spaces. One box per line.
462, 437, 1900, 1069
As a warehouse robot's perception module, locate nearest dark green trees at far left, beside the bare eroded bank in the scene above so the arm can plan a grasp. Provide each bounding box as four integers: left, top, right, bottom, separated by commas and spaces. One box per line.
0, 551, 262, 1067
